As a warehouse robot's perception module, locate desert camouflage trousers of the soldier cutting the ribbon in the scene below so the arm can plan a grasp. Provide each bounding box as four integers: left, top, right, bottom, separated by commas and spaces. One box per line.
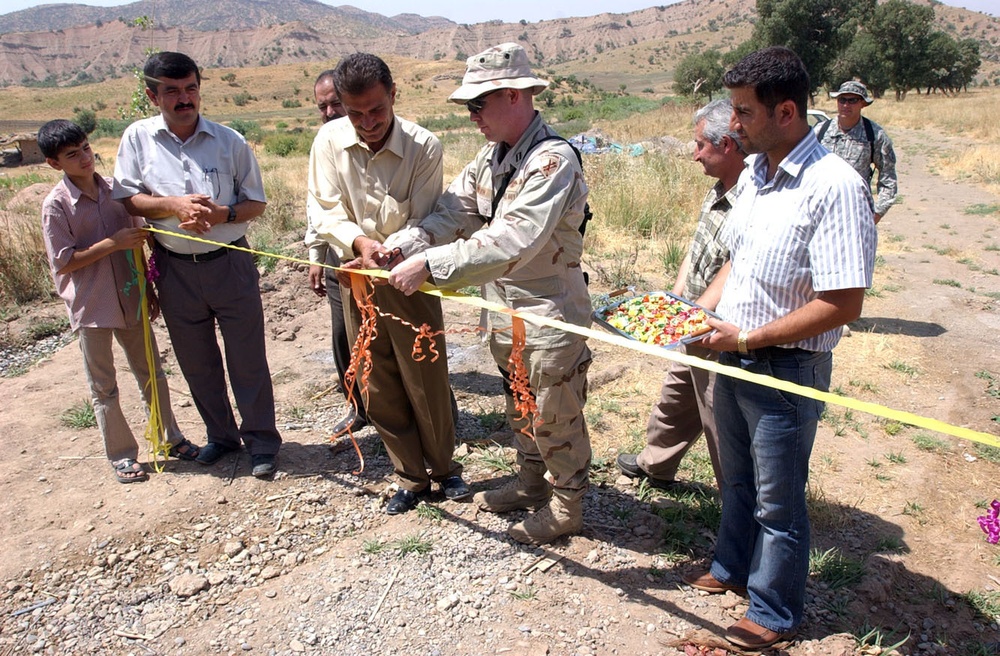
490, 339, 592, 494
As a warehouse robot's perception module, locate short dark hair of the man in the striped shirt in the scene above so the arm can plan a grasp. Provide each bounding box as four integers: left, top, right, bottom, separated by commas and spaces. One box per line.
722, 46, 809, 119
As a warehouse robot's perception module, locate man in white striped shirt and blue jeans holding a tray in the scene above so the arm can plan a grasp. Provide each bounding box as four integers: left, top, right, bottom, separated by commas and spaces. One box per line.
696, 47, 876, 649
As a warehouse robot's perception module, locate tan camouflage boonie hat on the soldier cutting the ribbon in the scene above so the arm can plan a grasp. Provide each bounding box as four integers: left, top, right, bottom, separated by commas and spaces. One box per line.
448, 43, 549, 105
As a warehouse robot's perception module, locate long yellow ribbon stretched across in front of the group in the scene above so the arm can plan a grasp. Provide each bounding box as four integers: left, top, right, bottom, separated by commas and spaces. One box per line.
147, 228, 1000, 449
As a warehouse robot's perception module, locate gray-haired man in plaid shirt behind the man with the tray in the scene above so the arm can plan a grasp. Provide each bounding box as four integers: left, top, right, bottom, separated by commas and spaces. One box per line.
617, 99, 745, 488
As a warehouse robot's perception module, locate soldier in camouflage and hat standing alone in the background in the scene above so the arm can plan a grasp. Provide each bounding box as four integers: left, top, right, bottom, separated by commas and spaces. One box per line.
814, 80, 897, 223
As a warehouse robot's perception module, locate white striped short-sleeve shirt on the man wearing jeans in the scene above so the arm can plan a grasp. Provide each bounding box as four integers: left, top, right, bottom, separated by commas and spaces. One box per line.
716, 131, 877, 351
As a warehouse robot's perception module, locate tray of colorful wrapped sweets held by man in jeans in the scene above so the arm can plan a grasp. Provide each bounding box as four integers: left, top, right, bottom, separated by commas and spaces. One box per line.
593, 291, 718, 348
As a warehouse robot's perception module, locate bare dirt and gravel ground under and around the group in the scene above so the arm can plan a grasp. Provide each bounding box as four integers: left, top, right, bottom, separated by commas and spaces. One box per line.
0, 125, 1000, 655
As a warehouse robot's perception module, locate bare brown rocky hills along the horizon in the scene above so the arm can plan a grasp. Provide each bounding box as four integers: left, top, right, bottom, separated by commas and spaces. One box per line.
0, 0, 1000, 86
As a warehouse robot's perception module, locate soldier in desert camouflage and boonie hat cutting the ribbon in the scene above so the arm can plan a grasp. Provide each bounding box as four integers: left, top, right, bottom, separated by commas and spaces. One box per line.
385, 43, 591, 544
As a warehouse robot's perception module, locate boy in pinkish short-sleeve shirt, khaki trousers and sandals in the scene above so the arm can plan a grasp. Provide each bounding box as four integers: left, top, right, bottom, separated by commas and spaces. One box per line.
38, 120, 199, 483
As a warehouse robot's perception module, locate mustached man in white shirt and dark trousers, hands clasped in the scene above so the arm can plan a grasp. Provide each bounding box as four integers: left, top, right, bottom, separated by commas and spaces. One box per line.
113, 52, 281, 478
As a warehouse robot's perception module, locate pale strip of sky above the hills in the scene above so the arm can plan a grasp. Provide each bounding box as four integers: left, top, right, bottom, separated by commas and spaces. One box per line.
0, 0, 1000, 23
